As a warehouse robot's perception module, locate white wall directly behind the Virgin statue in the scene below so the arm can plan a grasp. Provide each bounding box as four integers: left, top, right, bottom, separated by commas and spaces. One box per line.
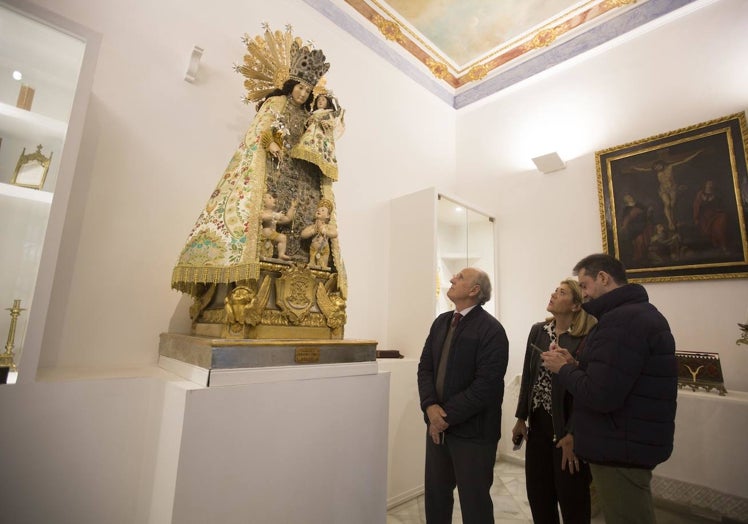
22, 0, 455, 372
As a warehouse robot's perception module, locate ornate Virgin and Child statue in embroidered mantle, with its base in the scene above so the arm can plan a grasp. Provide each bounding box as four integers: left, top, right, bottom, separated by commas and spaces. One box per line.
161, 25, 376, 376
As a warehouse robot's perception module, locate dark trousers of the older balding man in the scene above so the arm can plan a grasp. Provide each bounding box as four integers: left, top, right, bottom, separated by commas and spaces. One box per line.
425, 433, 498, 524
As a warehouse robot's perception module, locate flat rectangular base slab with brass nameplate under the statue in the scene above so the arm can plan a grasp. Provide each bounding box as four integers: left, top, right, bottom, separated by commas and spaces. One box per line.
159, 333, 377, 370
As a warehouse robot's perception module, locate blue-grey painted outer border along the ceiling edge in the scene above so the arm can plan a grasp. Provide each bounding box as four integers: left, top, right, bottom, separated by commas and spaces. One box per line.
304, 0, 699, 109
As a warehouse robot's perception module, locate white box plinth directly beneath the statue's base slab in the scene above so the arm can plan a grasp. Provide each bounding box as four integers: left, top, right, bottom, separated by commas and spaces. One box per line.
170, 365, 389, 524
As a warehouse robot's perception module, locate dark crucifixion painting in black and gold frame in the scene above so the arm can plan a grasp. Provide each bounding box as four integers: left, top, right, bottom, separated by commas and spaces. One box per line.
595, 113, 748, 282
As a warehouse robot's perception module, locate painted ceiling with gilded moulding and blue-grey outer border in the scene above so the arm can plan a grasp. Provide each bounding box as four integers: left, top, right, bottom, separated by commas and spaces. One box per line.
304, 0, 707, 108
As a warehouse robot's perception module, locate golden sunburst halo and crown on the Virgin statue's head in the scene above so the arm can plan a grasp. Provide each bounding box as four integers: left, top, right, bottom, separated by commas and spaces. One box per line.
234, 23, 330, 102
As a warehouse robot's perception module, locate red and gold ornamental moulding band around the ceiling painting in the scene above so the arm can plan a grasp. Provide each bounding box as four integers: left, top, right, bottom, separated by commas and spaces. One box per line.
344, 0, 637, 89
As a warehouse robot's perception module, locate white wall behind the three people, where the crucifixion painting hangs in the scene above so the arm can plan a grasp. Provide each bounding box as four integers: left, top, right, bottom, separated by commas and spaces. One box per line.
457, 0, 748, 396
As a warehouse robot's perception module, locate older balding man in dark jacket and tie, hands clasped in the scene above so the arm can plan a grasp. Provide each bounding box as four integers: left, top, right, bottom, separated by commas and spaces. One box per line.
418, 268, 509, 524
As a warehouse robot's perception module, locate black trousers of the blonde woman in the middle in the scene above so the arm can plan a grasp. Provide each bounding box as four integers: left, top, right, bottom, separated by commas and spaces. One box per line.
525, 408, 592, 524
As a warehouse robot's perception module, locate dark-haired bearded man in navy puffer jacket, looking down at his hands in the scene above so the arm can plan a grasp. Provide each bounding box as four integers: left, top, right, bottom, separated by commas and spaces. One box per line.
543, 254, 678, 524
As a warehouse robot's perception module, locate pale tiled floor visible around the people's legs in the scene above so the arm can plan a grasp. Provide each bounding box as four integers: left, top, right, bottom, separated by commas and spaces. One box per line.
387, 461, 715, 524
